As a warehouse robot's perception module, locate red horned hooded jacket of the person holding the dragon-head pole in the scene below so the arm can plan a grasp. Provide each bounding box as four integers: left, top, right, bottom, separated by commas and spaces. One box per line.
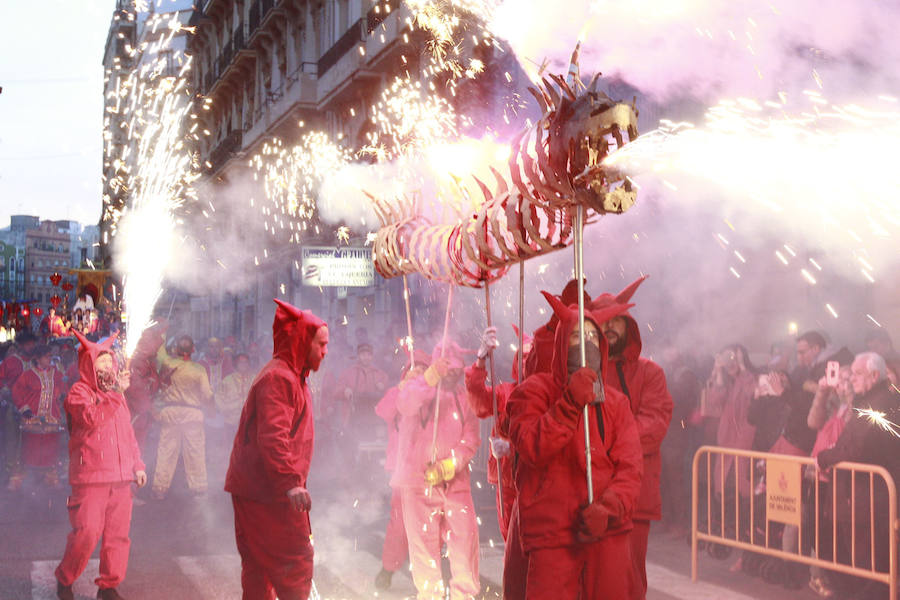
509, 294, 642, 552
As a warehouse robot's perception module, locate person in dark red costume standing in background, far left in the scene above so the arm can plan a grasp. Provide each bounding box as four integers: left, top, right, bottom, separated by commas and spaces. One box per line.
9, 345, 65, 491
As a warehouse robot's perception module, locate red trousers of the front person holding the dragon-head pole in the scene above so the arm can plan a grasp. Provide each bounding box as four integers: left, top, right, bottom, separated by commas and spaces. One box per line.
525, 533, 634, 600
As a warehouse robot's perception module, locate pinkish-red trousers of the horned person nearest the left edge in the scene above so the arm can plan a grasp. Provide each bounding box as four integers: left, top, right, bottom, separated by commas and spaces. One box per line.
56, 481, 131, 588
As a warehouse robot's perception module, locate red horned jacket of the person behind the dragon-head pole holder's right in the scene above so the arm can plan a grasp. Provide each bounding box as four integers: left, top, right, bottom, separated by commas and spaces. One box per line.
591, 276, 673, 521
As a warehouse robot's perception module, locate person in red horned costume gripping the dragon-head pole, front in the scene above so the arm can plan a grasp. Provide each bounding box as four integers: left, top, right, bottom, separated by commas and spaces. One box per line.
508, 292, 643, 600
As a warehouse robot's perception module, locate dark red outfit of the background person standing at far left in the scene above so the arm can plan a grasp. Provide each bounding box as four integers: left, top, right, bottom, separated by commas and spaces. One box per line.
12, 367, 65, 469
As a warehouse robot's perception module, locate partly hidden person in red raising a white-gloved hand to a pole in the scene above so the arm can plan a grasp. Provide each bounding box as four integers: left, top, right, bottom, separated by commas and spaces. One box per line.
466, 327, 518, 541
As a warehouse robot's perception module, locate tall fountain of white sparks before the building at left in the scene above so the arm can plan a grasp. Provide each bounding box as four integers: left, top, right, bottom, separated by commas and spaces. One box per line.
104, 13, 197, 356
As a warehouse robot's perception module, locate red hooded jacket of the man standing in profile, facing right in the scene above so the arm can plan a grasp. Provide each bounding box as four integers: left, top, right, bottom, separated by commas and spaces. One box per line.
225, 300, 325, 502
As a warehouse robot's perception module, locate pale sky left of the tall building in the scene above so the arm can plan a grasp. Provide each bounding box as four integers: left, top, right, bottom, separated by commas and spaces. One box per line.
0, 0, 115, 227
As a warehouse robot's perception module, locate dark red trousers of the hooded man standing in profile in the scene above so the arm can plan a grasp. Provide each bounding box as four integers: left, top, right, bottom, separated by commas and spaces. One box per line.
231, 496, 313, 600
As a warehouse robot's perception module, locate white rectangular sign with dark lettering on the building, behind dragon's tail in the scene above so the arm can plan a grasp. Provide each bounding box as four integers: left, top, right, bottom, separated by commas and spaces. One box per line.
301, 246, 375, 287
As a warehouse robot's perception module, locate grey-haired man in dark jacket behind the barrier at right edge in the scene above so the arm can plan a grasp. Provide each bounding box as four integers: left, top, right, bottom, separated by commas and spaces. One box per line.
816, 352, 900, 598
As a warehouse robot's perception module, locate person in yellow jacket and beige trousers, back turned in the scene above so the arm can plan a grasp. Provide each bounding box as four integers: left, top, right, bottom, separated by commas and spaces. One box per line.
152, 335, 213, 500
